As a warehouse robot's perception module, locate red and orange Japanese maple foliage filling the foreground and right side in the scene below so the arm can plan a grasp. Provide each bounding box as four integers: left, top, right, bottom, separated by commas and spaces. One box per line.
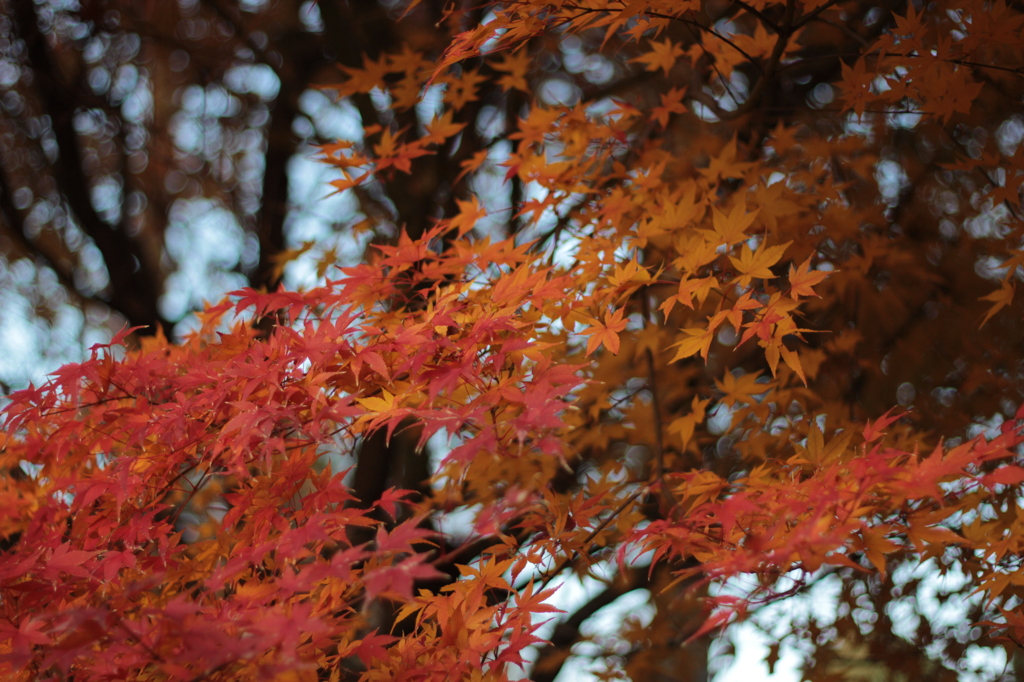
0, 0, 1024, 682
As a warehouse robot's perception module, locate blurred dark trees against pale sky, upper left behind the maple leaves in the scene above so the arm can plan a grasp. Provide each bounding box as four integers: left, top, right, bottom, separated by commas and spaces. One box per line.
0, 0, 452, 385
